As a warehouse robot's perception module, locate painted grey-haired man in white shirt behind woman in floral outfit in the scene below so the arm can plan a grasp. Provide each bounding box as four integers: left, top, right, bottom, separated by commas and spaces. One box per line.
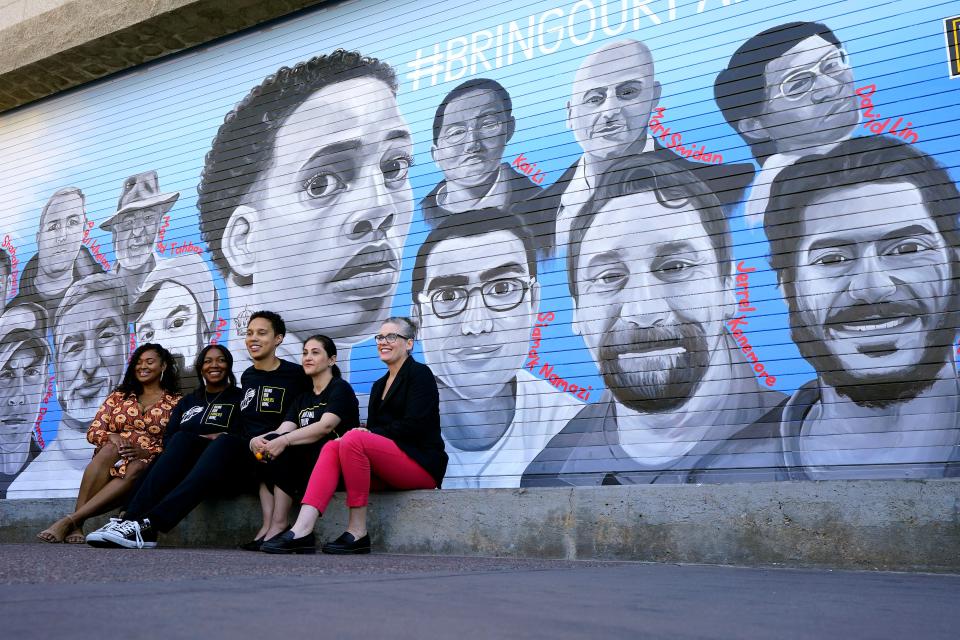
7, 273, 127, 498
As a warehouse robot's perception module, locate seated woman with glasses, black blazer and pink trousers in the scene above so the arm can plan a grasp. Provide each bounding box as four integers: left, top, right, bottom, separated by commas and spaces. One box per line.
262, 318, 447, 554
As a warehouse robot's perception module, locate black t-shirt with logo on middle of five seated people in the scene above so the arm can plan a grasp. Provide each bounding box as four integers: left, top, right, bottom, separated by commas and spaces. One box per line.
240, 360, 313, 438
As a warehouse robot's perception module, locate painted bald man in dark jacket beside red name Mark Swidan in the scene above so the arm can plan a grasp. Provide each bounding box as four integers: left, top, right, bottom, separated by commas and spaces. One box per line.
516, 40, 753, 251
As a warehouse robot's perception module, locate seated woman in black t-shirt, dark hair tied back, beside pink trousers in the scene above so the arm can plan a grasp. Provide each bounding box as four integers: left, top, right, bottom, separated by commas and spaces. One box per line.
250, 335, 360, 540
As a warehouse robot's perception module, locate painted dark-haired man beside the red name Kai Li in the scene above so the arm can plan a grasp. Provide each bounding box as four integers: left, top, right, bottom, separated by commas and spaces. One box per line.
420, 78, 543, 228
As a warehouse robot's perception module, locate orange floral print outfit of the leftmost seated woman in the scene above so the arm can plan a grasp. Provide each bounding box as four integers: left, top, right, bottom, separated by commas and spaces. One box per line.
87, 391, 180, 478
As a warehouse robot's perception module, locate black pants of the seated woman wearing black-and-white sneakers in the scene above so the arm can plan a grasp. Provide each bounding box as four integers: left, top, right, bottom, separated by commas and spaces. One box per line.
125, 431, 258, 532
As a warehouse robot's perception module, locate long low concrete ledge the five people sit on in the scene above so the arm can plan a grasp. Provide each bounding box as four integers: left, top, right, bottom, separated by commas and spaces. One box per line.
0, 480, 960, 571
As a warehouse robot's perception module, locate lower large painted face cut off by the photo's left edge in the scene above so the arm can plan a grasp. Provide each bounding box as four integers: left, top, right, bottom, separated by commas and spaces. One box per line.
0, 339, 48, 474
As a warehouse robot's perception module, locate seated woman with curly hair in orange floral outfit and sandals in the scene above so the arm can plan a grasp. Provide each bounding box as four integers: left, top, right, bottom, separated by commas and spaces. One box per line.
37, 343, 180, 544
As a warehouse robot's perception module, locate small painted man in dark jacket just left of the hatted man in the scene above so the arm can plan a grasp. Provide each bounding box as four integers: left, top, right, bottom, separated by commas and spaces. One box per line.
11, 187, 103, 322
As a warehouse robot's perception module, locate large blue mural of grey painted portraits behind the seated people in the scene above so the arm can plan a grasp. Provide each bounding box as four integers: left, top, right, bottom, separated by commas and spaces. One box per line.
0, 0, 960, 498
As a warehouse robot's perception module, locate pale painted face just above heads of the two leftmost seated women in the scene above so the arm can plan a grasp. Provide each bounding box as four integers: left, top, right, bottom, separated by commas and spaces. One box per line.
134, 280, 204, 373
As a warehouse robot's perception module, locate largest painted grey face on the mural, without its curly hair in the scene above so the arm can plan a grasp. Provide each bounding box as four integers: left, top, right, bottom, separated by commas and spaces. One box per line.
234, 78, 413, 340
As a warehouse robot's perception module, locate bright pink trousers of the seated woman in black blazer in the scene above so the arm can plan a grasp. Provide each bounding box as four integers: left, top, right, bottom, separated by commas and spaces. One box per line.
303, 430, 437, 513
